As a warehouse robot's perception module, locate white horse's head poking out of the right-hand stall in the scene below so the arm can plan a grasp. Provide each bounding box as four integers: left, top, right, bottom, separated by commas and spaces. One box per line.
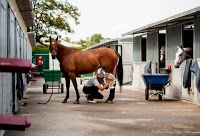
174, 45, 192, 68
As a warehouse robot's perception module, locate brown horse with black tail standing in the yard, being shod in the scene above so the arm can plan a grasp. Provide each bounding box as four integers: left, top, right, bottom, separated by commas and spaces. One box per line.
49, 37, 123, 104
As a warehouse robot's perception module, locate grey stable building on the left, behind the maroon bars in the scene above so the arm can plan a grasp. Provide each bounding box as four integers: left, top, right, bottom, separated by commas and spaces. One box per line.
0, 0, 35, 135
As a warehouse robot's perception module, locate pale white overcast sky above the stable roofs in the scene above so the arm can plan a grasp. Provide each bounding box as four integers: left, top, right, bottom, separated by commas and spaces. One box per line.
66, 0, 200, 41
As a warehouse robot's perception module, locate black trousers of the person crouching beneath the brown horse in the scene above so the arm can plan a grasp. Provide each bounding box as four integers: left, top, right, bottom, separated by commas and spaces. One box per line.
83, 86, 103, 100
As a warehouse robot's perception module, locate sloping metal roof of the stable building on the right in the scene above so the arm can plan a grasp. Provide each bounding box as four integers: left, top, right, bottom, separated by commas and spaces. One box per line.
122, 6, 200, 36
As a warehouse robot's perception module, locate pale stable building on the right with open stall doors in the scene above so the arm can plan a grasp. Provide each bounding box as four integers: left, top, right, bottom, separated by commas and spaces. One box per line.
122, 7, 200, 103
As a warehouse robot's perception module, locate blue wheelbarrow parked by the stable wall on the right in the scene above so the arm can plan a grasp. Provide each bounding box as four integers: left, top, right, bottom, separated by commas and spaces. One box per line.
142, 73, 170, 100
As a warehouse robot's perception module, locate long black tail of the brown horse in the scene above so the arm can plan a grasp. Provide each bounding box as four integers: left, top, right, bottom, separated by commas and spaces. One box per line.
115, 52, 123, 91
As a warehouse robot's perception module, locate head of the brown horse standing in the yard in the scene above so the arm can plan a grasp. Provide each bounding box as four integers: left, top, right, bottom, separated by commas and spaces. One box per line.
49, 36, 58, 59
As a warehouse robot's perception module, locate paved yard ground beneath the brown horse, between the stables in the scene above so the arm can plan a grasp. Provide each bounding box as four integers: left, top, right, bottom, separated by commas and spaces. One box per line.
5, 77, 200, 136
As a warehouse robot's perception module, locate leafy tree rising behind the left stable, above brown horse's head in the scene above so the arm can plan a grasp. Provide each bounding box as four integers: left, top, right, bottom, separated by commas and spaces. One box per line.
32, 0, 80, 42
